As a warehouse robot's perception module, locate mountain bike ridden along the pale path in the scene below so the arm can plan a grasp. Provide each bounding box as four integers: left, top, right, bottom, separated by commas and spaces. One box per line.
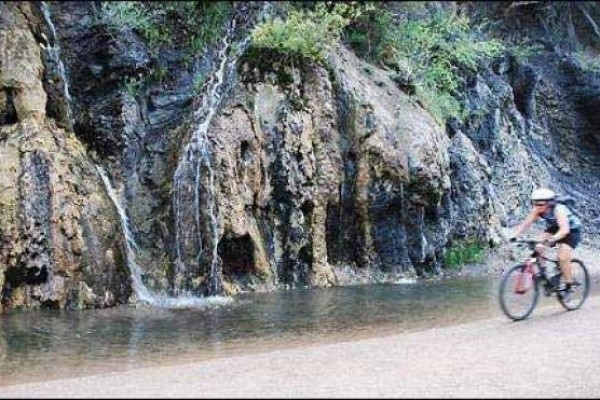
499, 239, 590, 321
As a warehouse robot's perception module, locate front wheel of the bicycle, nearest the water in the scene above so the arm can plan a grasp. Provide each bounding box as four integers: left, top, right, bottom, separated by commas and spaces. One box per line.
499, 264, 540, 321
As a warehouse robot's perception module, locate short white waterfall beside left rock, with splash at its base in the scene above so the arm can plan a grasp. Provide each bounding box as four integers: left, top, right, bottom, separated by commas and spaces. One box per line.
96, 165, 232, 308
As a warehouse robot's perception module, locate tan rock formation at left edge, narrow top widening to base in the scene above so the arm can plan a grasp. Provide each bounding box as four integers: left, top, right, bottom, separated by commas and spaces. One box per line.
0, 3, 131, 308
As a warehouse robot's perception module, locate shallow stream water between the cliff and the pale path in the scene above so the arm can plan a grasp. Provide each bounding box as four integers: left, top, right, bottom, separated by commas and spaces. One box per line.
0, 278, 499, 385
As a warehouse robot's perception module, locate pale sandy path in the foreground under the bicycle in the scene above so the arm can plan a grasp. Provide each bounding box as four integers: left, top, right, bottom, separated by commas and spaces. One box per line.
0, 296, 600, 398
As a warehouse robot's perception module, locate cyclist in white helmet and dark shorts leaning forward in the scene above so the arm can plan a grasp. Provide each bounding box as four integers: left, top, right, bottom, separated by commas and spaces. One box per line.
510, 188, 581, 300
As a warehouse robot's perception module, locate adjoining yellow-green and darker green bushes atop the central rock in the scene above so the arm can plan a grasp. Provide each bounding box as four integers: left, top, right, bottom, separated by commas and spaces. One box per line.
253, 2, 506, 122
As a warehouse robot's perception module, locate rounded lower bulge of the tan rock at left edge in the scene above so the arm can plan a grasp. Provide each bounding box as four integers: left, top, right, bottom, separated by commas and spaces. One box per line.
0, 121, 130, 308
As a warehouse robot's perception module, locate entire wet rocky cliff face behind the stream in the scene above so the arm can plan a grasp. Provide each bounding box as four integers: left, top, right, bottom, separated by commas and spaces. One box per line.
0, 2, 600, 308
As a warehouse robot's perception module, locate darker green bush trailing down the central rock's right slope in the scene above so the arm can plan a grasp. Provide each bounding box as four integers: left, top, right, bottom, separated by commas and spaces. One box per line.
347, 5, 506, 122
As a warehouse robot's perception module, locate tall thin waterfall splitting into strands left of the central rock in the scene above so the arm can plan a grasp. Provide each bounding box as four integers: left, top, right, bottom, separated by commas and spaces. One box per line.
173, 18, 250, 294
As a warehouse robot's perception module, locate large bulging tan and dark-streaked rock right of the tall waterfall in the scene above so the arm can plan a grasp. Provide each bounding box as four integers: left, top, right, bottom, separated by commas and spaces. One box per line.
202, 49, 450, 286
